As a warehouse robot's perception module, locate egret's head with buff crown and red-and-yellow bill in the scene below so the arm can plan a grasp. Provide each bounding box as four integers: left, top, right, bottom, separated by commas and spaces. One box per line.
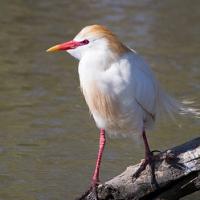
47, 25, 129, 59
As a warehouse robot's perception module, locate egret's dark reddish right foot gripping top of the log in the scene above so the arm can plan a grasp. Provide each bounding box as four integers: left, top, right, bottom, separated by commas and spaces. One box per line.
132, 150, 160, 185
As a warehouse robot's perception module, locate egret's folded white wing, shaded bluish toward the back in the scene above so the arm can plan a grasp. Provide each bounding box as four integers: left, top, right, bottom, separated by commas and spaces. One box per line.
103, 52, 157, 119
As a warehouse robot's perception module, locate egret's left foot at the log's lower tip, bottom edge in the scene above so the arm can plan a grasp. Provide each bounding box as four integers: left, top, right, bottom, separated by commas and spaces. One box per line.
75, 182, 100, 200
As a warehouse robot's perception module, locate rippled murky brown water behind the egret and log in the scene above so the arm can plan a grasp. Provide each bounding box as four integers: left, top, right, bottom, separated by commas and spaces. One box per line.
0, 0, 200, 200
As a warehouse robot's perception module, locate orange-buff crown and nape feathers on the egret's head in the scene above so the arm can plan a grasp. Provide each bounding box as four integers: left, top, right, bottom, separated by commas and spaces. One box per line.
76, 25, 130, 56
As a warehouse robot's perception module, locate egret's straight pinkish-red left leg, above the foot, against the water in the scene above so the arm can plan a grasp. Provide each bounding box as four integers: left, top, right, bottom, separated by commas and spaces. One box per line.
92, 129, 106, 185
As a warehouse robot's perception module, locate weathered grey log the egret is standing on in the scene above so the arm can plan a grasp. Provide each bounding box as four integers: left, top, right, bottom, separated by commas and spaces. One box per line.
85, 137, 200, 200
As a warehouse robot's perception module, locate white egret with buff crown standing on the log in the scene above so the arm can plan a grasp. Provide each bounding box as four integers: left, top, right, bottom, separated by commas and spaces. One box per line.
47, 25, 179, 198
